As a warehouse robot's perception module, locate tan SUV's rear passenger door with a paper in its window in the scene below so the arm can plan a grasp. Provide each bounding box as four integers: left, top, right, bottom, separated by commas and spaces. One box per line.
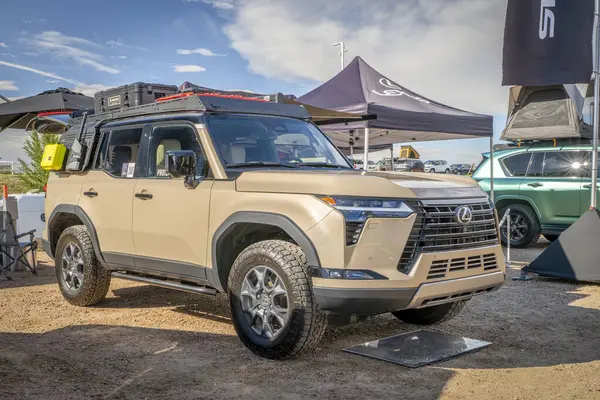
78, 126, 142, 265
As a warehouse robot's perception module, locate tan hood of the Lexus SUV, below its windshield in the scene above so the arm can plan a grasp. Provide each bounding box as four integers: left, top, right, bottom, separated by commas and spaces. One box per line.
236, 170, 486, 199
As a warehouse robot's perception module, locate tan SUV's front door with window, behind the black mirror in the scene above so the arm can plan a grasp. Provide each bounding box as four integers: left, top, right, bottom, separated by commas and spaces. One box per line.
132, 122, 213, 280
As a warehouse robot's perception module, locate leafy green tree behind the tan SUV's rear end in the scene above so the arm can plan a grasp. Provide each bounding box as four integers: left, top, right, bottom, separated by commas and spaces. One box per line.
19, 131, 58, 190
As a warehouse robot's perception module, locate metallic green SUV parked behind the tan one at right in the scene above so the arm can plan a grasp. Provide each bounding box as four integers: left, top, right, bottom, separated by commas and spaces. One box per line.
473, 146, 592, 247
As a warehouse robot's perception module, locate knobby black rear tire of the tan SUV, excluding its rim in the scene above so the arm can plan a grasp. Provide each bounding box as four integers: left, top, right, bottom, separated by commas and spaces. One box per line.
55, 225, 110, 307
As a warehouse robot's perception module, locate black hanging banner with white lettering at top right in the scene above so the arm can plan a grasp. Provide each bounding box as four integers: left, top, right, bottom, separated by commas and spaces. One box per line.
502, 0, 594, 86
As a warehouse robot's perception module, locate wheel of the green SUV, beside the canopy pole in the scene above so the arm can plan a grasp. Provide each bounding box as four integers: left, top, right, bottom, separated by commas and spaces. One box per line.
500, 204, 541, 248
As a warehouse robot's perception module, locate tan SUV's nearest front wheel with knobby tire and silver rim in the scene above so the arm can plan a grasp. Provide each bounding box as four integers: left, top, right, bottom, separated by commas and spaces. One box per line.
228, 240, 326, 359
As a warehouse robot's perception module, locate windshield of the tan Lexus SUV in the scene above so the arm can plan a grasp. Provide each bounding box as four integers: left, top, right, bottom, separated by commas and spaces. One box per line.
206, 114, 352, 168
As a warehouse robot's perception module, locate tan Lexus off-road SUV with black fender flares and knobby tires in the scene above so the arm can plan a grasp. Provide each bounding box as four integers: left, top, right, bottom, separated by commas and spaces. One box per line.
44, 91, 505, 358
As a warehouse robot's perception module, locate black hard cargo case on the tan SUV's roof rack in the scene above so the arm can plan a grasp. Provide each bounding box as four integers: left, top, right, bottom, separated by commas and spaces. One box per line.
94, 82, 177, 114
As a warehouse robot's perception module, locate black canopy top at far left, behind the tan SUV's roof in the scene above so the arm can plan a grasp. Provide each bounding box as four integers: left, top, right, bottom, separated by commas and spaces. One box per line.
0, 88, 94, 132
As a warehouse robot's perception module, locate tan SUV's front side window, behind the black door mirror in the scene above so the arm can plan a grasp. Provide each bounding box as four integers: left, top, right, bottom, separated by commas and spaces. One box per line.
148, 125, 207, 177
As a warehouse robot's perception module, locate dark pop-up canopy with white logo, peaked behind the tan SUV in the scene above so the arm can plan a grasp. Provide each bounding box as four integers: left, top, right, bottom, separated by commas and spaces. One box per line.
298, 57, 493, 149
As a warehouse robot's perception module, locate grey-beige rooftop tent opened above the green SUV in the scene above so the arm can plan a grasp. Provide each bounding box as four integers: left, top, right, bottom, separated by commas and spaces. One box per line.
501, 85, 591, 140
